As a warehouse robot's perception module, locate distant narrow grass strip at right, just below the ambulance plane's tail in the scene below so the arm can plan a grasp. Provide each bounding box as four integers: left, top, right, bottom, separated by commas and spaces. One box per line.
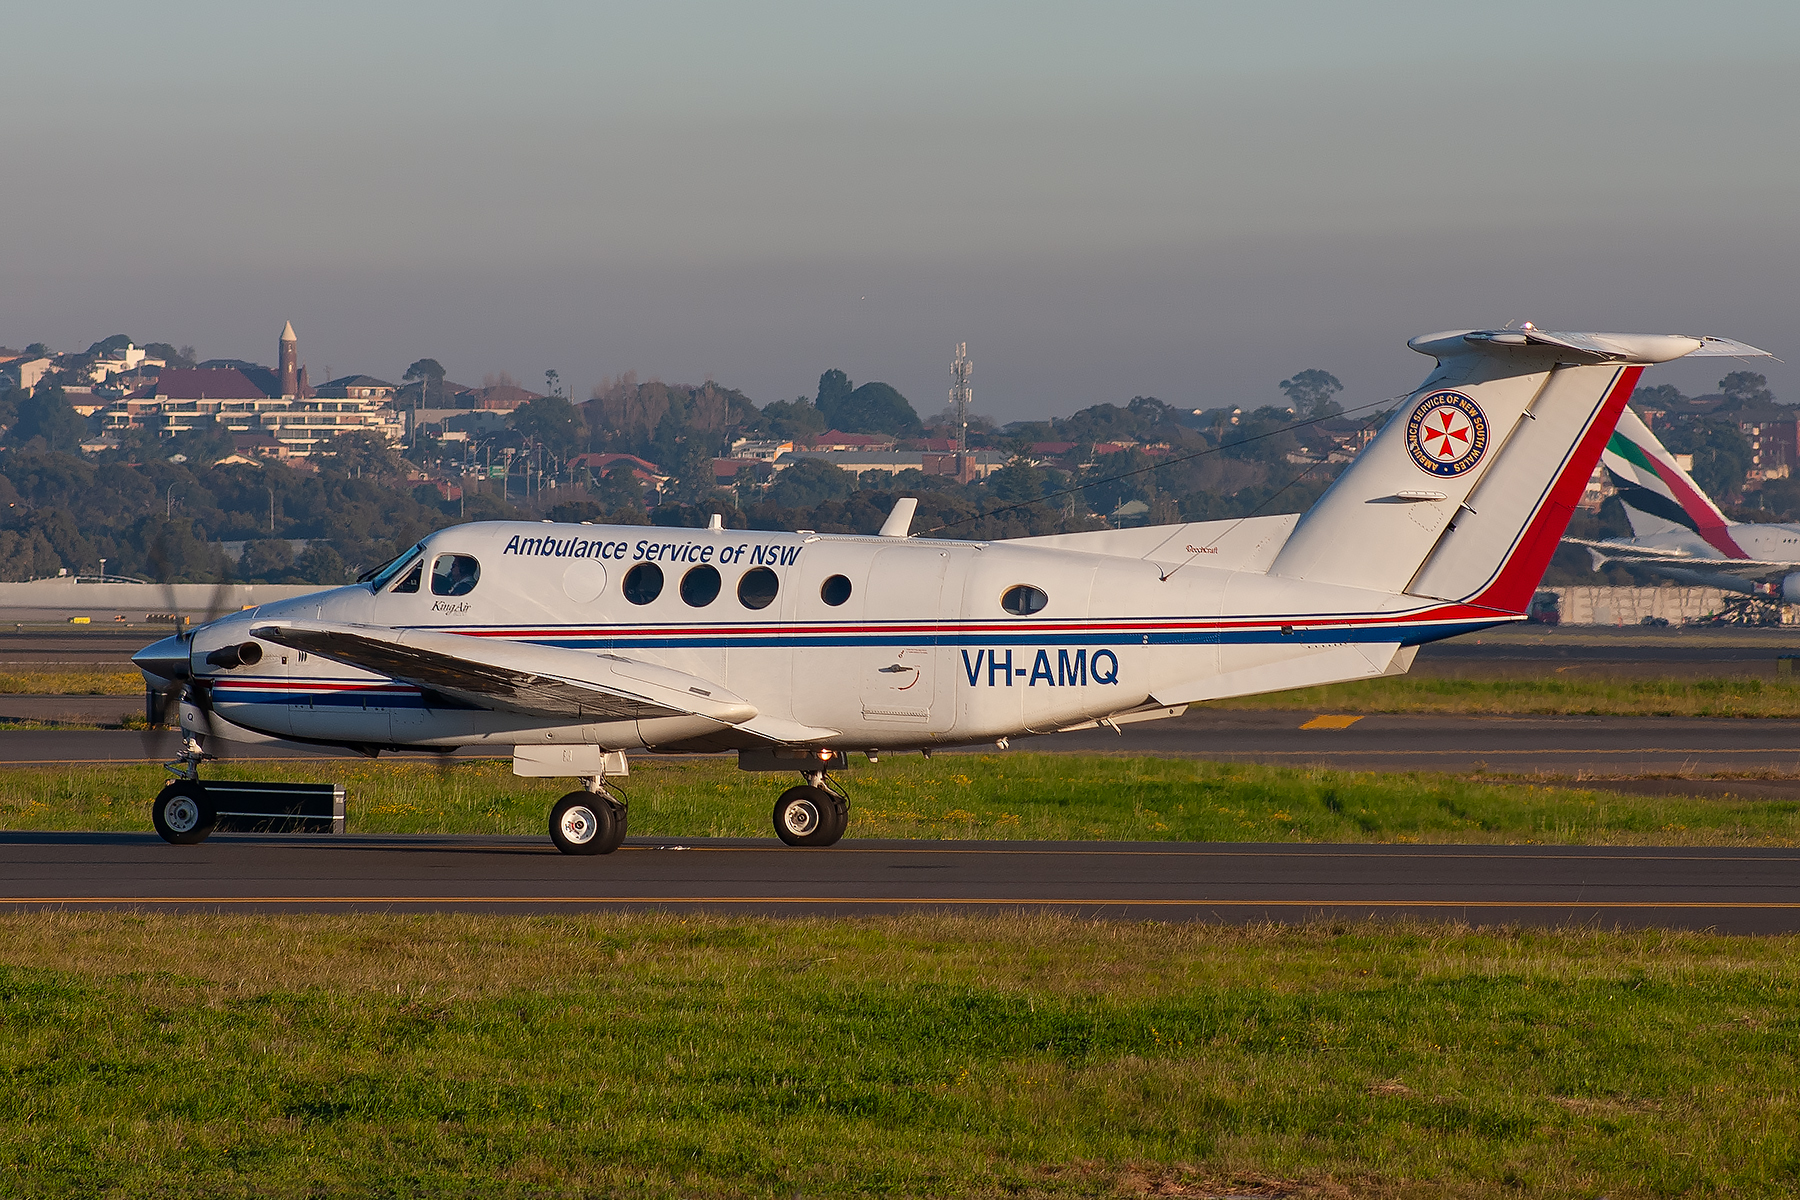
1206, 675, 1800, 718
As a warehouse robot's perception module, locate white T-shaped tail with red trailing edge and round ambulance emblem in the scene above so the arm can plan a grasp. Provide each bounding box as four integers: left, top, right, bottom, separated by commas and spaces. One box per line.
1269, 329, 1764, 613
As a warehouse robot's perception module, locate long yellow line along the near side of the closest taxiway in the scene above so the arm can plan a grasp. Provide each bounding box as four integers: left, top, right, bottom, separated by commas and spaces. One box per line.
0, 896, 1800, 910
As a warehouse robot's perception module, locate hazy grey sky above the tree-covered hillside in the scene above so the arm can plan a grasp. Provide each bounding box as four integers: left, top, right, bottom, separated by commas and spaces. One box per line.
0, 0, 1800, 421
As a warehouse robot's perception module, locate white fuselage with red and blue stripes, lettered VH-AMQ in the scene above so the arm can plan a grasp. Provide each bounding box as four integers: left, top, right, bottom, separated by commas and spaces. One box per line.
165, 522, 1517, 750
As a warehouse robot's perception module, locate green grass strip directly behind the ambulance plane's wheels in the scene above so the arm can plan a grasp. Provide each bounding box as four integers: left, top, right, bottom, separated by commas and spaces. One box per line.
0, 752, 1800, 846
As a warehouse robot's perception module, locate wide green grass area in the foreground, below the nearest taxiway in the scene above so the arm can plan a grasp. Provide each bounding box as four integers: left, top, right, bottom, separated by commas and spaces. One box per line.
0, 914, 1800, 1198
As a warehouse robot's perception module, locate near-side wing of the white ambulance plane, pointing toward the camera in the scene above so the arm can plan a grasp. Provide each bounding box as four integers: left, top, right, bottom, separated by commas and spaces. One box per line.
250, 621, 756, 725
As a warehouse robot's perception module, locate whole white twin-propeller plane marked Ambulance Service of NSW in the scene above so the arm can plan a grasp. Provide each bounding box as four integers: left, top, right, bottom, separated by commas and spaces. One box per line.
133, 326, 1760, 855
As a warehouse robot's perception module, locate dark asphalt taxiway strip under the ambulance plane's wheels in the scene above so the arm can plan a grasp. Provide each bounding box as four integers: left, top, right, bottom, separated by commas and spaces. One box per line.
0, 833, 1800, 934
